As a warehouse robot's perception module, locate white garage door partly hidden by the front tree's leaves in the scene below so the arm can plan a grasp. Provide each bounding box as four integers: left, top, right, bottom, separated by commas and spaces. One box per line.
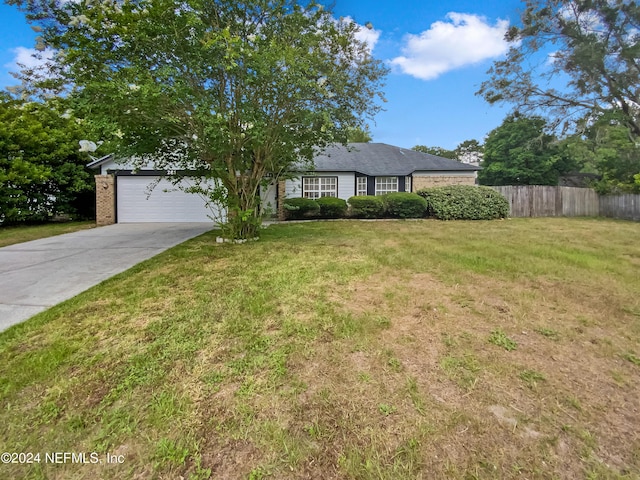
116, 176, 223, 223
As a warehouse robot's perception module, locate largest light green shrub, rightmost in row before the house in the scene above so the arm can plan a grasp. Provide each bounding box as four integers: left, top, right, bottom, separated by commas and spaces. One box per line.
417, 185, 509, 220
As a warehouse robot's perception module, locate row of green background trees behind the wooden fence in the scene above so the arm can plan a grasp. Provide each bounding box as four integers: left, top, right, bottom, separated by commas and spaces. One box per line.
413, 111, 640, 193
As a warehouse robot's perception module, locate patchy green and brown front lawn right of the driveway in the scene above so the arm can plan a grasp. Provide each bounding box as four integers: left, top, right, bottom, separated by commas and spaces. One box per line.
0, 218, 640, 480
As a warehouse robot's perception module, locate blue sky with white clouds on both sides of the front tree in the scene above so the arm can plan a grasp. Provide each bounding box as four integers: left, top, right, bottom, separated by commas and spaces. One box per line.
0, 0, 523, 149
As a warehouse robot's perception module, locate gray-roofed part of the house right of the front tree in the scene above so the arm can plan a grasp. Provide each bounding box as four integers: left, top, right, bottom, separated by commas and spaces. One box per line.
278, 143, 480, 217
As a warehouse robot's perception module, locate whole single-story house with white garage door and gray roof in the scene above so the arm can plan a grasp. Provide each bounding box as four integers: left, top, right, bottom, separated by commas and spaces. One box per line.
89, 143, 479, 225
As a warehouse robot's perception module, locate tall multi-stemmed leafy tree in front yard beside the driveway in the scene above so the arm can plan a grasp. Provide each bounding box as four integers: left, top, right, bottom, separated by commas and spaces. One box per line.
9, 0, 386, 238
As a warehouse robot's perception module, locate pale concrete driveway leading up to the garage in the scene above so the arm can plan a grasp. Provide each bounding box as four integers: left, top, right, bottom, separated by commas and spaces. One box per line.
0, 223, 214, 331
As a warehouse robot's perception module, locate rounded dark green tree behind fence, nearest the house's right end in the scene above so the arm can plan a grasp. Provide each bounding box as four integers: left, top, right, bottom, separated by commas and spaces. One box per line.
478, 116, 576, 185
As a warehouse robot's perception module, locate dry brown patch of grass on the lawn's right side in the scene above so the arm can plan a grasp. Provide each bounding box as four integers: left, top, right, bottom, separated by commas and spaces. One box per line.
335, 272, 640, 476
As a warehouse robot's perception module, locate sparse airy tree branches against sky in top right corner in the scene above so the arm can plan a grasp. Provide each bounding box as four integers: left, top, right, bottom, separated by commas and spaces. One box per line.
478, 0, 640, 137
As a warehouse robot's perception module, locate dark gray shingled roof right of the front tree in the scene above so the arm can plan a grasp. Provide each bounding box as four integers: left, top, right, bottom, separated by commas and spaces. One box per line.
302, 143, 480, 176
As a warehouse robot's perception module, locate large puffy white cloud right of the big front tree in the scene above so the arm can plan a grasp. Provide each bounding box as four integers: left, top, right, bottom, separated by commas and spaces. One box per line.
391, 12, 509, 80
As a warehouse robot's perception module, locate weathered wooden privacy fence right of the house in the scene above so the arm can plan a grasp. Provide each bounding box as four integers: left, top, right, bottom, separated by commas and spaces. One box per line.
491, 185, 640, 221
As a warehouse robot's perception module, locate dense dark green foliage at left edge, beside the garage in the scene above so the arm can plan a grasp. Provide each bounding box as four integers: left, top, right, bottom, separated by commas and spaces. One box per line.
0, 95, 95, 224
